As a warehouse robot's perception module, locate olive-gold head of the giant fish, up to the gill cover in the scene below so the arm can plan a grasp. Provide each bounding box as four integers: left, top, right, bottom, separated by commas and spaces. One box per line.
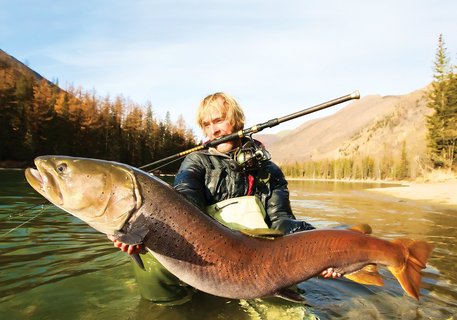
25, 156, 142, 234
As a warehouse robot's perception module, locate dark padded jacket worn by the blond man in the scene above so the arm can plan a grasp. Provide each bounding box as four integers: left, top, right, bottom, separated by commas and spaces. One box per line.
174, 147, 314, 234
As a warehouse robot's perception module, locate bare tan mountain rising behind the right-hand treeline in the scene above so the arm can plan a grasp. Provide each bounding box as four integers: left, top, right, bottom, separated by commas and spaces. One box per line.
256, 87, 432, 164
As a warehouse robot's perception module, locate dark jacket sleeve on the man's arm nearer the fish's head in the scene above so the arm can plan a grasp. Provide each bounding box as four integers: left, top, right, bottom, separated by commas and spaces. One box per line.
173, 152, 207, 210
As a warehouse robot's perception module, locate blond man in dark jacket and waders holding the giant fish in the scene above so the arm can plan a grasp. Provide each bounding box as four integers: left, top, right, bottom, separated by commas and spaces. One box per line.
110, 92, 341, 301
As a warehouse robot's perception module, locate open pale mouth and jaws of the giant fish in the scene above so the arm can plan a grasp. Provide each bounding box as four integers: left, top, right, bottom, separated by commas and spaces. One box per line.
25, 159, 63, 205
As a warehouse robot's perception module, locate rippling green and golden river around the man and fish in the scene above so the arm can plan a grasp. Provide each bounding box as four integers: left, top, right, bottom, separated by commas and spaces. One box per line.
0, 170, 457, 320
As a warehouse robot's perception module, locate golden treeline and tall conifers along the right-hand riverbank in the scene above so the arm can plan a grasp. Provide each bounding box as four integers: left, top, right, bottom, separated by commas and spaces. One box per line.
281, 35, 457, 180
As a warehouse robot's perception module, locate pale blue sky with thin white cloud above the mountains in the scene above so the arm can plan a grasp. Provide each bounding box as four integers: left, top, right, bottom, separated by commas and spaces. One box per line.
0, 0, 457, 135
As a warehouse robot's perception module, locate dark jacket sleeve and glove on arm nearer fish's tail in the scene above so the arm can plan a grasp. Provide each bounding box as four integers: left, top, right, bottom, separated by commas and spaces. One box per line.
265, 163, 315, 234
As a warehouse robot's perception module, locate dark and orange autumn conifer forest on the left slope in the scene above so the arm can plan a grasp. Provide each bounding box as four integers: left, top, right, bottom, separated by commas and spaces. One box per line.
0, 53, 196, 172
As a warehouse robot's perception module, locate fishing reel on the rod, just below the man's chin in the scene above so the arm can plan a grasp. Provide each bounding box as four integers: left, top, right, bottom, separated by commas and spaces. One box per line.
230, 136, 271, 171
